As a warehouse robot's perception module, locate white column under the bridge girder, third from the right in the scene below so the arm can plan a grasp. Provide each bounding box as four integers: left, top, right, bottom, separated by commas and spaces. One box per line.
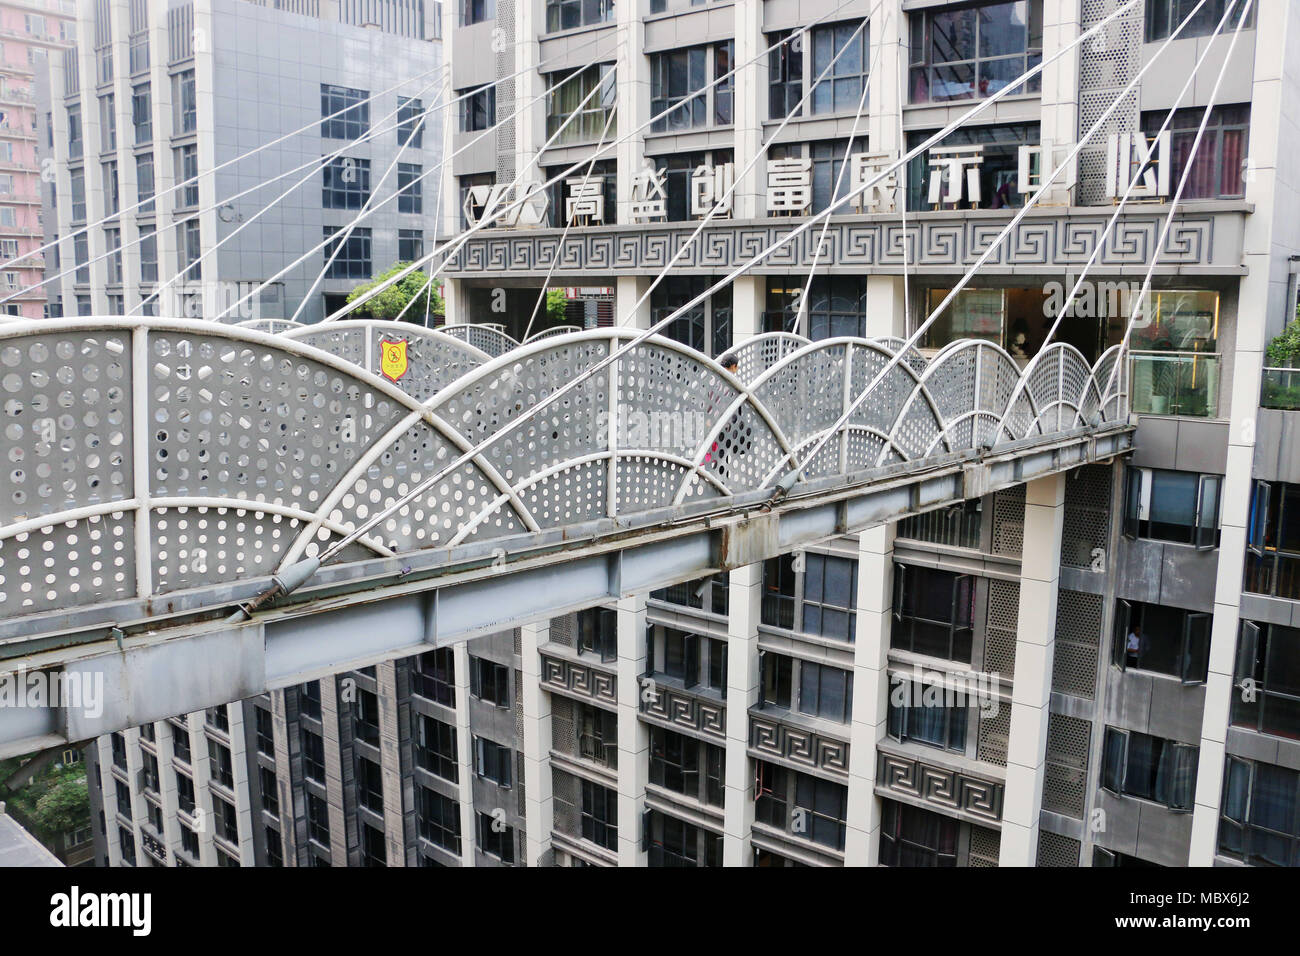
723, 563, 763, 866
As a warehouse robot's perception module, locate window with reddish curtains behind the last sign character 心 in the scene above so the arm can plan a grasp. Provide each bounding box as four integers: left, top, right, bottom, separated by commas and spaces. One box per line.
1141, 103, 1251, 199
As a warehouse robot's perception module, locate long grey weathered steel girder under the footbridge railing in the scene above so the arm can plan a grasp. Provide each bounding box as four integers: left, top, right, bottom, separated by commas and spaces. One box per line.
0, 424, 1134, 757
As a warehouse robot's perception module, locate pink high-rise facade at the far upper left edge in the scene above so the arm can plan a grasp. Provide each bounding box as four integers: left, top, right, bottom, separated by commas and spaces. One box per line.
0, 0, 75, 319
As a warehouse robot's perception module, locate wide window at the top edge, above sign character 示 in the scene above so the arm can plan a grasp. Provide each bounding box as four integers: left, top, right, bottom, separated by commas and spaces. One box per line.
907, 0, 1043, 103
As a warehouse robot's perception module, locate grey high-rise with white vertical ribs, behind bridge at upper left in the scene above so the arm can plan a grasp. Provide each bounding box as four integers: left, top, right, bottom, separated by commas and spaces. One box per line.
34, 0, 445, 323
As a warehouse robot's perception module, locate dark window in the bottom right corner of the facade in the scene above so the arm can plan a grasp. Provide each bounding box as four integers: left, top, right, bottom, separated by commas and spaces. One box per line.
1218, 757, 1300, 866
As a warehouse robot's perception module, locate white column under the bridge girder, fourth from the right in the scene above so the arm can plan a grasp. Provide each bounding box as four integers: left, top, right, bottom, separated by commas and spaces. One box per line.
615, 594, 650, 866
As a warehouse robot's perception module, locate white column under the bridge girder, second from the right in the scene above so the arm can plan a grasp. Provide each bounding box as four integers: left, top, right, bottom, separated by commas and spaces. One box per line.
844, 524, 897, 866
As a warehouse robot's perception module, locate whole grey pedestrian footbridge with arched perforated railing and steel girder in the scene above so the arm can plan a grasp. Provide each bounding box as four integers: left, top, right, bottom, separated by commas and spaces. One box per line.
0, 317, 1132, 756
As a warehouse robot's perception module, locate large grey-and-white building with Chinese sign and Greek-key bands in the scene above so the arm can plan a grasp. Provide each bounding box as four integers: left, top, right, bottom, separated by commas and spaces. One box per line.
81, 0, 1300, 866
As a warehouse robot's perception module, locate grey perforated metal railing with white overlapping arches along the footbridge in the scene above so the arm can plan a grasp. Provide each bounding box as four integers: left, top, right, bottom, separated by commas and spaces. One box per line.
0, 317, 1127, 617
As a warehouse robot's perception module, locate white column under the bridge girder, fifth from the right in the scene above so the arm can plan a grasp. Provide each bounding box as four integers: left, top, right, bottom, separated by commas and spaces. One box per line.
519, 622, 555, 866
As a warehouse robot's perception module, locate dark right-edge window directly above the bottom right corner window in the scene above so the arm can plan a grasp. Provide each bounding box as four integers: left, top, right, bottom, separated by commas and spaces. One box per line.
1232, 620, 1300, 740
